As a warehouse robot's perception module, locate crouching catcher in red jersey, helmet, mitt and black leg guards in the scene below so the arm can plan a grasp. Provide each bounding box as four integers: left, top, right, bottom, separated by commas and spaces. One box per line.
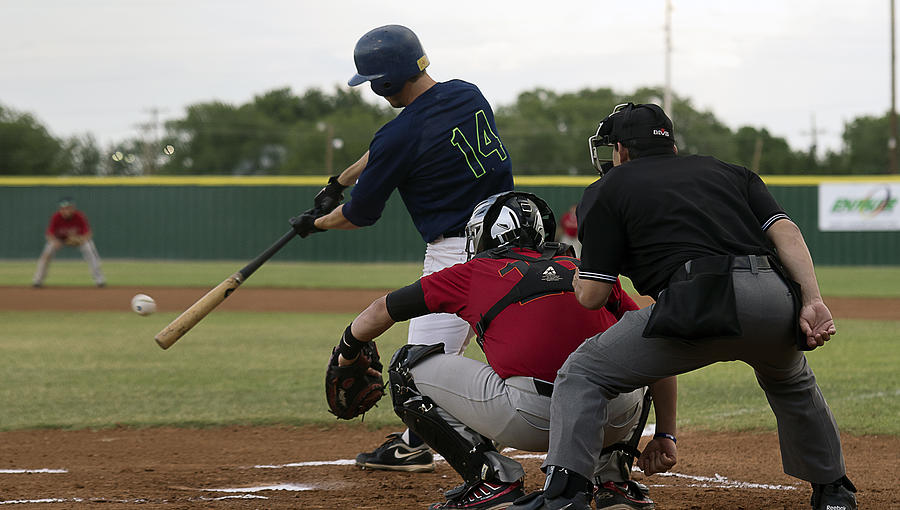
326, 192, 676, 509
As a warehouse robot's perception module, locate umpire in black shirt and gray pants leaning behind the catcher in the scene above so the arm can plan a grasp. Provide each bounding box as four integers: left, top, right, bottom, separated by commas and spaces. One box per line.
512, 103, 857, 510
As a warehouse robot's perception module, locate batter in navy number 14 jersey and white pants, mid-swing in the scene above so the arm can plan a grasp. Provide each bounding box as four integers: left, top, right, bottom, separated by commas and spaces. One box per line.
291, 25, 513, 470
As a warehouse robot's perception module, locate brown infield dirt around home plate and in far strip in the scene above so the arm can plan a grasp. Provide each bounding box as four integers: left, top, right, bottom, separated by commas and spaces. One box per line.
0, 287, 900, 510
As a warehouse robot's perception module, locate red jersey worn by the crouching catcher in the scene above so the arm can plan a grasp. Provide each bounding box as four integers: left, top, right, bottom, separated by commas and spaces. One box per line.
421, 250, 639, 381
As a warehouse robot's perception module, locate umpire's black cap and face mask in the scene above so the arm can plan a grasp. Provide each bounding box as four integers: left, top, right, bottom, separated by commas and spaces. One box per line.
588, 103, 675, 176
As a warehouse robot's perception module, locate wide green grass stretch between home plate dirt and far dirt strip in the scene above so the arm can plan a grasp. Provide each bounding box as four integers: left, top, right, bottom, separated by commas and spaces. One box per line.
0, 311, 900, 435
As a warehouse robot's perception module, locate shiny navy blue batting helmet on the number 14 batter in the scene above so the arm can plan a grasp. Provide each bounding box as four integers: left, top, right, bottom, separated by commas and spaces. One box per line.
347, 25, 428, 96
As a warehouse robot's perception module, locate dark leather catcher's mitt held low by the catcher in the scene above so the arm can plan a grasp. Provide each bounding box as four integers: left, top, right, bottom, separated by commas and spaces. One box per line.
325, 341, 384, 420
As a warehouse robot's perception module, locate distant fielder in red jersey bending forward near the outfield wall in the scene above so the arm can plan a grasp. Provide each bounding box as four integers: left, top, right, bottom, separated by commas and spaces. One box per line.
31, 198, 106, 288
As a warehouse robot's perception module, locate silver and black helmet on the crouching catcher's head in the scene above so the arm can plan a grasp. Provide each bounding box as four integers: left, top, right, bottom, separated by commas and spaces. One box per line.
466, 191, 556, 260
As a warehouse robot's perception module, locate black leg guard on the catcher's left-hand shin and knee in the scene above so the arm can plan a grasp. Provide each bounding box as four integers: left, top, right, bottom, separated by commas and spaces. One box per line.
388, 344, 496, 483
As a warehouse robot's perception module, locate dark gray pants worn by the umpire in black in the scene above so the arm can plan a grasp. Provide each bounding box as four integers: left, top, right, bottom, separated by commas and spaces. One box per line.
544, 269, 845, 483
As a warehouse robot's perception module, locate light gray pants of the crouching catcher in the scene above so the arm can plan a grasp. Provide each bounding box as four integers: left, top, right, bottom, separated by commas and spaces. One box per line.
411, 354, 646, 482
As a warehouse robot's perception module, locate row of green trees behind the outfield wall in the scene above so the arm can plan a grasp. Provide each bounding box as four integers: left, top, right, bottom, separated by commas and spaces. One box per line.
0, 88, 889, 175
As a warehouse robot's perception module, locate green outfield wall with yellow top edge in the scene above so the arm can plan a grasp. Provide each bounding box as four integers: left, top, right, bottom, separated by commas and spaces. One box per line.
0, 176, 900, 265
